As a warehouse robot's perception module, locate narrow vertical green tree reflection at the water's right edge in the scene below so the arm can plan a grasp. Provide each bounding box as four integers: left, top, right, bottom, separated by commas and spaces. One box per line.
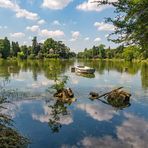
141, 63, 148, 89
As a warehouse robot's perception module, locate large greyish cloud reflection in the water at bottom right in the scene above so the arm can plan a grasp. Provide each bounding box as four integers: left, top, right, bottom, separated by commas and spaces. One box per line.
63, 113, 148, 148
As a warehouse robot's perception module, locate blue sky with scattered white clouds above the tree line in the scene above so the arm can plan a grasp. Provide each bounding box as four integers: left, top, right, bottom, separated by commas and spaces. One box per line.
0, 0, 117, 52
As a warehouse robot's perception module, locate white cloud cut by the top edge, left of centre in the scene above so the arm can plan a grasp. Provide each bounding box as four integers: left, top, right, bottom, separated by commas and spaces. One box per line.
42, 0, 73, 10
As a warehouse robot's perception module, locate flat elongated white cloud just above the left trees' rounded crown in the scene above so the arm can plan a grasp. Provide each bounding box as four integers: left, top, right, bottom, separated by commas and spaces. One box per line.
40, 29, 65, 37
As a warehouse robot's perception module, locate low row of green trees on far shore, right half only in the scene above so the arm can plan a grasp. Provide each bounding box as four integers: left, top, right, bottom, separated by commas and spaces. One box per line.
77, 44, 148, 61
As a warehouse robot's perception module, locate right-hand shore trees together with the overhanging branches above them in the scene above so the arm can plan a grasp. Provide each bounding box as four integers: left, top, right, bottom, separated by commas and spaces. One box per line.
82, 0, 148, 61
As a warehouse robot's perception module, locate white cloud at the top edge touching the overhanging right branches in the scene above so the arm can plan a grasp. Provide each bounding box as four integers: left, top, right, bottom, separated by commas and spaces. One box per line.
76, 0, 110, 11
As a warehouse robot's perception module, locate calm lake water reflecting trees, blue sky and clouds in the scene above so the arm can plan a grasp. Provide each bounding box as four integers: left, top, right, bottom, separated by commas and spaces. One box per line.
0, 60, 148, 148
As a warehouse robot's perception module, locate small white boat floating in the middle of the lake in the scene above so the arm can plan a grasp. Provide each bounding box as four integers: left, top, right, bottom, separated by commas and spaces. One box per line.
75, 66, 95, 74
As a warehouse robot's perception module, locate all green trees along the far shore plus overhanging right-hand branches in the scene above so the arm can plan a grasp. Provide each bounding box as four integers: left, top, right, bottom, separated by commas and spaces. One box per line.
0, 0, 148, 61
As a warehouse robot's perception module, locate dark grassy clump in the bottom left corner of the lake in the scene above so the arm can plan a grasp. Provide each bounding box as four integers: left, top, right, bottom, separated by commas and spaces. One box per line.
0, 93, 29, 148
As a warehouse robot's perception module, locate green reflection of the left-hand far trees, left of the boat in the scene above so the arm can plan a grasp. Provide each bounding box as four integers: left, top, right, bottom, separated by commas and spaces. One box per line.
0, 59, 74, 80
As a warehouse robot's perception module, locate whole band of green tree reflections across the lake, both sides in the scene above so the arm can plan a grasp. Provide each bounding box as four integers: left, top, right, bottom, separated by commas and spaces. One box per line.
0, 59, 148, 88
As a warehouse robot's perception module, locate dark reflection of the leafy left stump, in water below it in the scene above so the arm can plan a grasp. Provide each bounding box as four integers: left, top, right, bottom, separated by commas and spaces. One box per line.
48, 100, 70, 133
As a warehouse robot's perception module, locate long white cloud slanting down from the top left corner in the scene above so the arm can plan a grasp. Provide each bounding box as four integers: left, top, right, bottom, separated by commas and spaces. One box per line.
0, 0, 38, 20
